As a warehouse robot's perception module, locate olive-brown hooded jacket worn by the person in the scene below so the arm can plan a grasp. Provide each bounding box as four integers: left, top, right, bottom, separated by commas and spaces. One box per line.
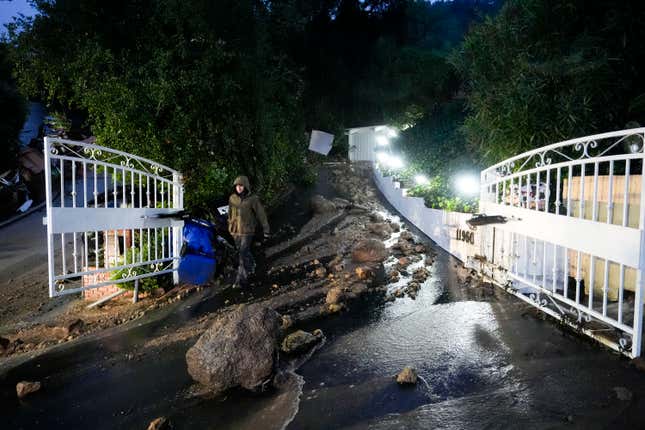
228, 176, 269, 236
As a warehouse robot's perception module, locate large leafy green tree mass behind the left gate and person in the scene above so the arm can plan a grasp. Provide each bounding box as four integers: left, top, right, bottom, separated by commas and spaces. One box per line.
10, 0, 306, 213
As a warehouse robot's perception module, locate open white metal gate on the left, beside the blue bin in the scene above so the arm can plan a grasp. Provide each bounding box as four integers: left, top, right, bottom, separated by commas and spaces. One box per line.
45, 137, 183, 297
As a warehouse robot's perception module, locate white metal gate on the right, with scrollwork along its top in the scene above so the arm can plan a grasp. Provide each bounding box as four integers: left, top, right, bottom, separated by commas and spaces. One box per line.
480, 128, 645, 357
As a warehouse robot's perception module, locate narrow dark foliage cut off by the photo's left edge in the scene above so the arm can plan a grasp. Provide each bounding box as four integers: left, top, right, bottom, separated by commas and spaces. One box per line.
0, 43, 27, 173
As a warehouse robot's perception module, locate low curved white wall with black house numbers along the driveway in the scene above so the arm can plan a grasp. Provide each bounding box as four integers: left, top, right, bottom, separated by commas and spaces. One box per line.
374, 168, 482, 263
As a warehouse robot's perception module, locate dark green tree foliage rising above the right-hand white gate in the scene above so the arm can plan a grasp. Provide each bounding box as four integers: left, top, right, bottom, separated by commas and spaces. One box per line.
452, 0, 645, 164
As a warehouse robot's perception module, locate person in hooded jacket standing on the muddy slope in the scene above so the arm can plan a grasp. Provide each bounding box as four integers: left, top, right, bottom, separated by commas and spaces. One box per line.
228, 176, 269, 287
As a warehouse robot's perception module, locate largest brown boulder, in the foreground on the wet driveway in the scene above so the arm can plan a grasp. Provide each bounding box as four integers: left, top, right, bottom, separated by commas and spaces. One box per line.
186, 305, 280, 394
